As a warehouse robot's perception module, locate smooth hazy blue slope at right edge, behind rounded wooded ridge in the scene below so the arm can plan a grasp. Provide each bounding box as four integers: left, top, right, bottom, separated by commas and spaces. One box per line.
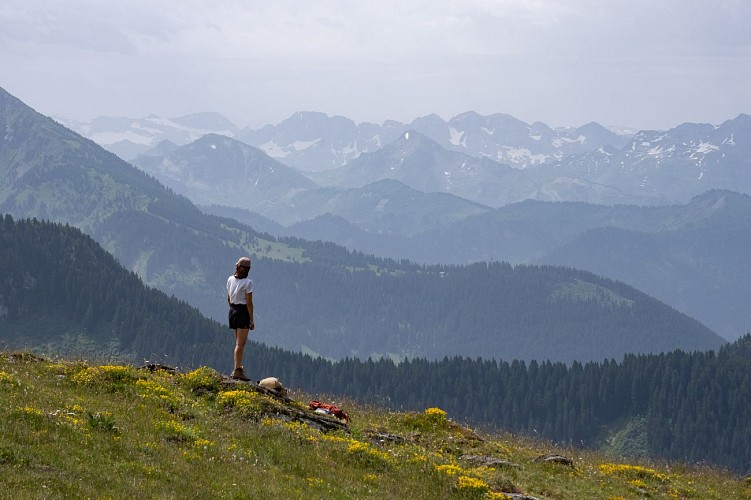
541, 191, 751, 339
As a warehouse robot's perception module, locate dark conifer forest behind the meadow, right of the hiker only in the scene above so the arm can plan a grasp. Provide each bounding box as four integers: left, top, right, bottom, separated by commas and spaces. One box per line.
251, 334, 751, 473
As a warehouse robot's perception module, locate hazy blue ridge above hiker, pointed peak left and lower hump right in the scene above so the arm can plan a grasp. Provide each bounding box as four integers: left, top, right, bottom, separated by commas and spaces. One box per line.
133, 139, 488, 229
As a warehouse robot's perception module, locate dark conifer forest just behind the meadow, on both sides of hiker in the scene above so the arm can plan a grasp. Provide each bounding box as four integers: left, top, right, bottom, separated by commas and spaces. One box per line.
0, 215, 751, 473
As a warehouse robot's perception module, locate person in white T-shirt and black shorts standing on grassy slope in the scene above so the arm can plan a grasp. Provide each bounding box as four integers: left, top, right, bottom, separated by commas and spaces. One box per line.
227, 257, 256, 381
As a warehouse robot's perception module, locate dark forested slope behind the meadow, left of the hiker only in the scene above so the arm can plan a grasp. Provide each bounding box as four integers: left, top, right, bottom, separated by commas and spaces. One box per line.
0, 215, 230, 366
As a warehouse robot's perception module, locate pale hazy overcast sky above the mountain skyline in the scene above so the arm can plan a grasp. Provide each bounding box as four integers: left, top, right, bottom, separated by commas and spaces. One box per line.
0, 0, 751, 129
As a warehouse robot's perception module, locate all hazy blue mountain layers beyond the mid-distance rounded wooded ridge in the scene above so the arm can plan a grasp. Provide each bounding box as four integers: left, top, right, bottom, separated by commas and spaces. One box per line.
66, 107, 751, 346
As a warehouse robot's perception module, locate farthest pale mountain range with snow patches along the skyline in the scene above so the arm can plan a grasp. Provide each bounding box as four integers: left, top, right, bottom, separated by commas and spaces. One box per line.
57, 111, 630, 171
